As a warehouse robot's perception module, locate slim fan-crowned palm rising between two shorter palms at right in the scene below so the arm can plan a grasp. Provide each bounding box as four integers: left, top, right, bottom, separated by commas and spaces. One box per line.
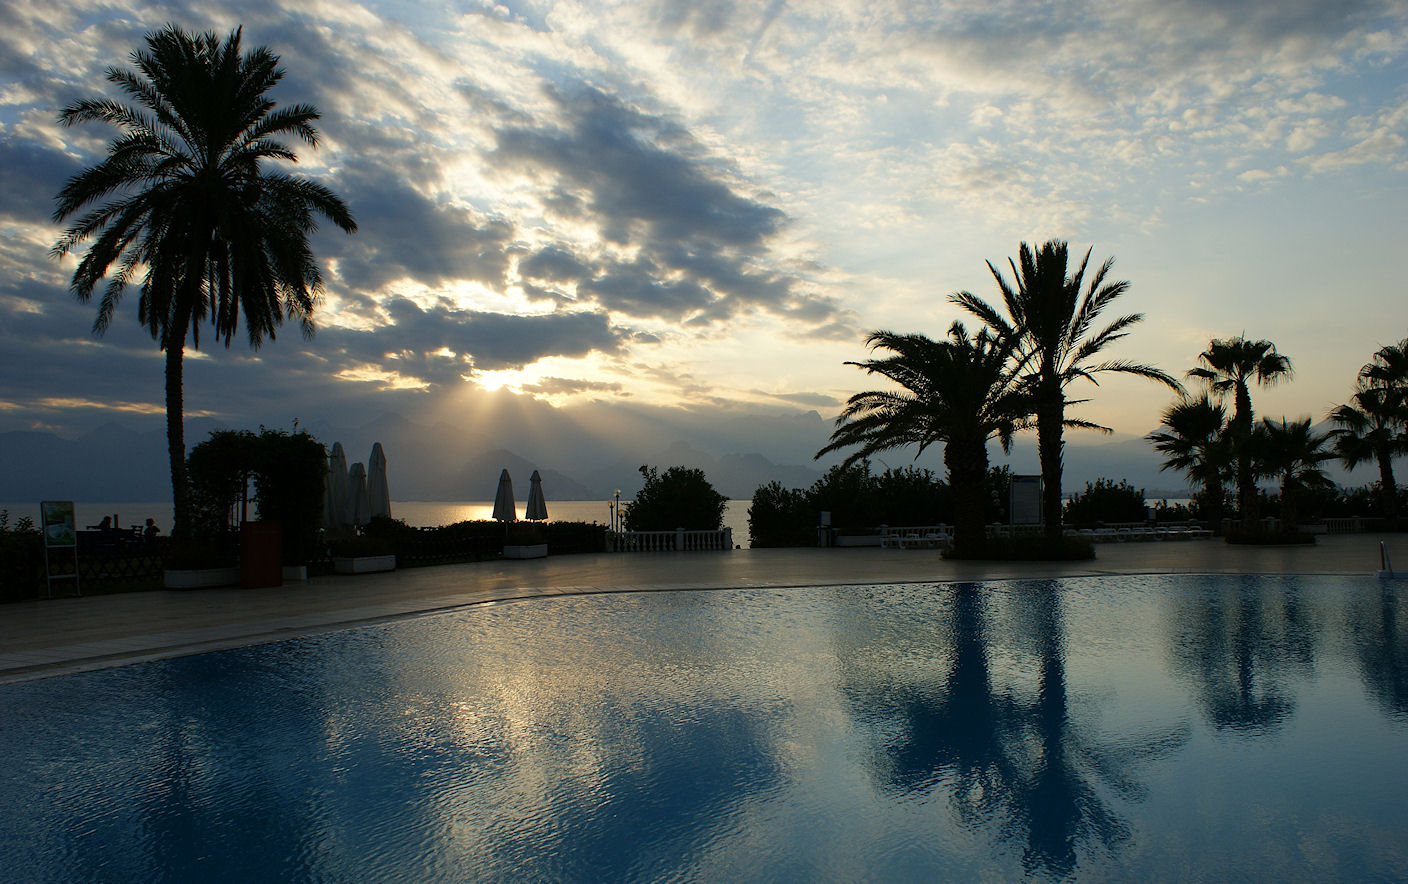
1188, 335, 1291, 532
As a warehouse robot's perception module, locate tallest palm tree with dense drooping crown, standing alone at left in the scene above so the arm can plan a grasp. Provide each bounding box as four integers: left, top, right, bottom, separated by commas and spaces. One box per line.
54, 25, 356, 536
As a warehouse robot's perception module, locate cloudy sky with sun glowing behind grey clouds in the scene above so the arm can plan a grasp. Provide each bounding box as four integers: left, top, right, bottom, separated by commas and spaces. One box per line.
0, 0, 1408, 467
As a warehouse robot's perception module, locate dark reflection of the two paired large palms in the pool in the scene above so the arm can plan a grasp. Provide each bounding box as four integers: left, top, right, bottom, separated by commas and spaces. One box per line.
843, 584, 1190, 876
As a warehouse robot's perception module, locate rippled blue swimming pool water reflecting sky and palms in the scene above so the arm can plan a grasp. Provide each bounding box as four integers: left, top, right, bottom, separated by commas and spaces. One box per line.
0, 577, 1408, 881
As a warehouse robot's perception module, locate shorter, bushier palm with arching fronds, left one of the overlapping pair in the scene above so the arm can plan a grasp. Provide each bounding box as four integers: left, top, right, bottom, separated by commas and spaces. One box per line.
817, 322, 1031, 555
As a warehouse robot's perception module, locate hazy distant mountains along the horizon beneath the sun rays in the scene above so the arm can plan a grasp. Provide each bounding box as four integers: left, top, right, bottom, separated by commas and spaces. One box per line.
0, 408, 1374, 503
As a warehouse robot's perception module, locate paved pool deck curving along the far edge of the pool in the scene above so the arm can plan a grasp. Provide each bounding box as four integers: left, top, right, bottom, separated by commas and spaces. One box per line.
0, 535, 1408, 684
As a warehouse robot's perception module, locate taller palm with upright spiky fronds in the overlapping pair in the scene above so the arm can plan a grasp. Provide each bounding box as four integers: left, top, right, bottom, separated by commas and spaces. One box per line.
949, 239, 1183, 536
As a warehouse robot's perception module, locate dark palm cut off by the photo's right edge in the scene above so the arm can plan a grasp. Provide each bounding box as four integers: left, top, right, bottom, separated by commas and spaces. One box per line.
1329, 341, 1408, 519
